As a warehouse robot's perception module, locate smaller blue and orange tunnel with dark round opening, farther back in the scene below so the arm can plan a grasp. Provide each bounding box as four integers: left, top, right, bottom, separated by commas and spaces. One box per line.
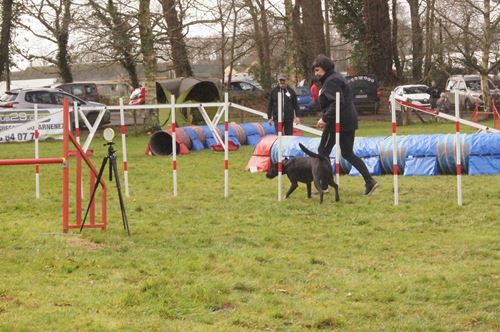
146, 122, 282, 156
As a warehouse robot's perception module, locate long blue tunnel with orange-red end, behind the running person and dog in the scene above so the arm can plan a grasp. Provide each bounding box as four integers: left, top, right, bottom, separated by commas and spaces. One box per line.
246, 133, 500, 176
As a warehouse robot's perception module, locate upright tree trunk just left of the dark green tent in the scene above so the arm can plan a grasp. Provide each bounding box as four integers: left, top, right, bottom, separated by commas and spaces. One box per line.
139, 0, 160, 131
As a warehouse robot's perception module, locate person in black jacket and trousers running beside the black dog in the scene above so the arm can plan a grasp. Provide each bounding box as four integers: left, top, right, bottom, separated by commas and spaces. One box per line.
313, 55, 378, 196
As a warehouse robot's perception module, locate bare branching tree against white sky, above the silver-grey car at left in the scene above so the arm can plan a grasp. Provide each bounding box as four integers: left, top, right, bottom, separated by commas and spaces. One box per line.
19, 0, 74, 82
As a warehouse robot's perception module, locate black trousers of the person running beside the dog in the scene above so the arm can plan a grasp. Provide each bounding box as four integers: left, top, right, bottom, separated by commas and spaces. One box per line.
318, 123, 373, 183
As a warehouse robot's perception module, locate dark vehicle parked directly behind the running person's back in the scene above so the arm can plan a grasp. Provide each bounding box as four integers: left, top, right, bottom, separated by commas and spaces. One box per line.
346, 75, 381, 114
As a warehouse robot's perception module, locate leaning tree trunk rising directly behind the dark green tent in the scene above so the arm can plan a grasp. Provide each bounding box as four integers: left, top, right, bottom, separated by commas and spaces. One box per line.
161, 0, 193, 77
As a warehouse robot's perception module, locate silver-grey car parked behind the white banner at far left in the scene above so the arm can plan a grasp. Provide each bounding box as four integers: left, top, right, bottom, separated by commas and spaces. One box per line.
0, 88, 110, 125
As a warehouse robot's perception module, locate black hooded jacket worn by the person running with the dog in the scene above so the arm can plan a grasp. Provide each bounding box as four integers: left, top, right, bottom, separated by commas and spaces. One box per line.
319, 69, 358, 131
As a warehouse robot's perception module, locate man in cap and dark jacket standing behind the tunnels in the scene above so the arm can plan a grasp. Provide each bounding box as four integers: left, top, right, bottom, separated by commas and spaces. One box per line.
267, 74, 299, 135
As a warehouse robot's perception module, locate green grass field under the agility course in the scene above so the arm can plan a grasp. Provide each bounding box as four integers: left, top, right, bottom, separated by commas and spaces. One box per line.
0, 120, 500, 331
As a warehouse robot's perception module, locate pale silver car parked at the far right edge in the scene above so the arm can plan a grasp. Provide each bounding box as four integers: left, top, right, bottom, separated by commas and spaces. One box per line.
445, 75, 500, 111
